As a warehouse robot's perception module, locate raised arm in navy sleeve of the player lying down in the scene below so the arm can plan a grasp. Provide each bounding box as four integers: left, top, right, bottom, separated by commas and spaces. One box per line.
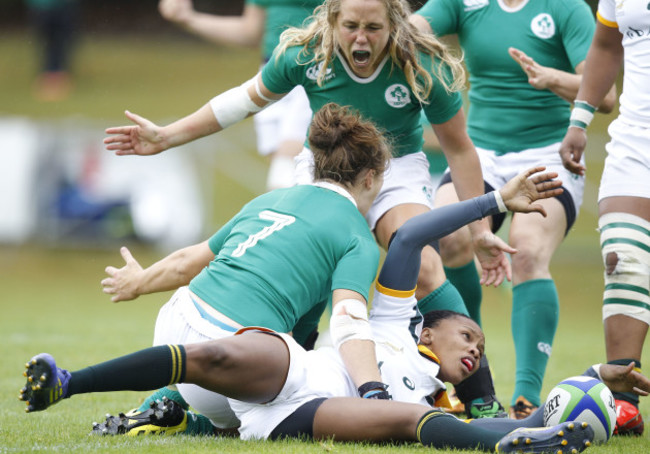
379, 167, 562, 291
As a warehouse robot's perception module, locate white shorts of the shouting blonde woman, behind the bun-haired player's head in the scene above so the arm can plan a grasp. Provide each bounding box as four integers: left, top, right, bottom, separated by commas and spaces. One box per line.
296, 148, 433, 230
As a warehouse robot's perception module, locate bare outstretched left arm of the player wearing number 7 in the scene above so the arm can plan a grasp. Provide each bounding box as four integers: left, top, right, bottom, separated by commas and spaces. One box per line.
102, 241, 214, 303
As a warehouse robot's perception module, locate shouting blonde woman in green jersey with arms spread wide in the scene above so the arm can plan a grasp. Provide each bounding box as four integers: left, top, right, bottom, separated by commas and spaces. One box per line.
105, 0, 514, 366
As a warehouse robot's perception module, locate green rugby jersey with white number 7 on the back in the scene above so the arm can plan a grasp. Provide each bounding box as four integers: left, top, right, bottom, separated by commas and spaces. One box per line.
189, 185, 379, 332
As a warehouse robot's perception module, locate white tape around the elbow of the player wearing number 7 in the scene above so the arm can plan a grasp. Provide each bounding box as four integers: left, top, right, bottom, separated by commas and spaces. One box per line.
330, 299, 373, 349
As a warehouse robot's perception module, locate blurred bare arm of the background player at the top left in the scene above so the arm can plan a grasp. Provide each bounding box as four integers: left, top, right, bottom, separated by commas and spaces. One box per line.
158, 0, 266, 47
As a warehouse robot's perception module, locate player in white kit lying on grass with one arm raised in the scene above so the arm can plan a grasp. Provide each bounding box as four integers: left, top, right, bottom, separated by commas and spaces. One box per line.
21, 168, 593, 452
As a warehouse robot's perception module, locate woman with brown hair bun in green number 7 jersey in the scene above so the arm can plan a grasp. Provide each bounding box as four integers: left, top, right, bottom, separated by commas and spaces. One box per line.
102, 104, 391, 428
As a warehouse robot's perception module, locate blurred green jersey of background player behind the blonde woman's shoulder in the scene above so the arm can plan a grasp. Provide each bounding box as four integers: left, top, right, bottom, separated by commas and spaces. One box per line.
246, 0, 323, 61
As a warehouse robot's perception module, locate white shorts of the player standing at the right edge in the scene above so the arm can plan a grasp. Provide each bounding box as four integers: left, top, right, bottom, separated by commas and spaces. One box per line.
598, 119, 650, 202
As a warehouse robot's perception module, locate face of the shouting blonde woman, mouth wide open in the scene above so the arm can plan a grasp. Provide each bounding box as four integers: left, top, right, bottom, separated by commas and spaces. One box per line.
335, 0, 390, 77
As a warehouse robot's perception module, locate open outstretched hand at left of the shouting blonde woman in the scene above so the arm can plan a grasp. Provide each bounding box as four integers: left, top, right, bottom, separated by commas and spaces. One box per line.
104, 110, 168, 156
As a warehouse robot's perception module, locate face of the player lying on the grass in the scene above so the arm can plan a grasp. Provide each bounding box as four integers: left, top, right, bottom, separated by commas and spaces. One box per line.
423, 317, 485, 384
